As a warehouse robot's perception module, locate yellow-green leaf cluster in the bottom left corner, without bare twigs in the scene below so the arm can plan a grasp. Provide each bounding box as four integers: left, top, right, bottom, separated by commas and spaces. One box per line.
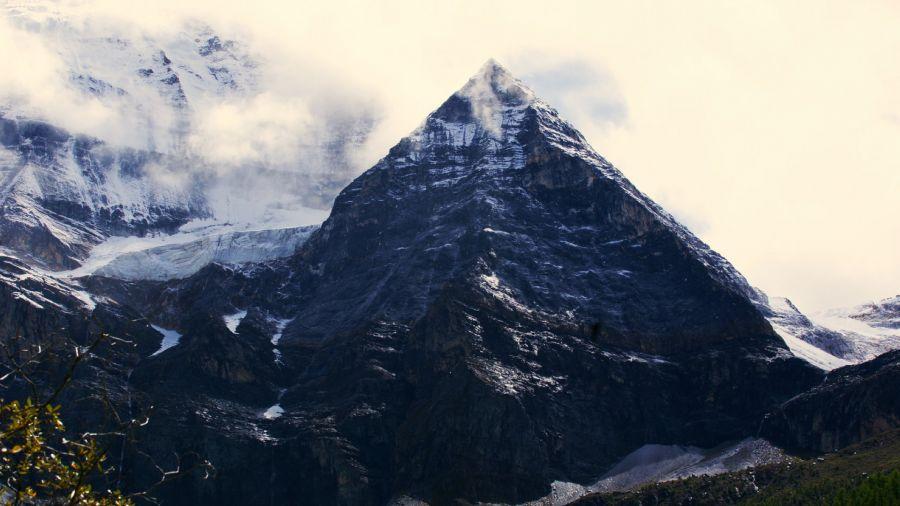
0, 399, 133, 506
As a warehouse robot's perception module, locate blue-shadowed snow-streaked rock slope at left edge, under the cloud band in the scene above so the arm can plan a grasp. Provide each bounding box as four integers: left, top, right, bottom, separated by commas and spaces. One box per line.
0, 115, 209, 269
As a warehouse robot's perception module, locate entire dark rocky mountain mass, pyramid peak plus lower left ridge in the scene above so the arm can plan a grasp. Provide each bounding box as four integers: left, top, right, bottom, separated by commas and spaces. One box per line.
0, 58, 896, 504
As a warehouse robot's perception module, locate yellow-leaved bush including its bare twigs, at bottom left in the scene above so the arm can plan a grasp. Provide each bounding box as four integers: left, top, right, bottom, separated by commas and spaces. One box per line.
0, 332, 215, 506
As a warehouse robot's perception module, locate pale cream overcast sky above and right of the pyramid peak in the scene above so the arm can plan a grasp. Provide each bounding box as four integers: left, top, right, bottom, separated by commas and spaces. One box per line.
0, 0, 900, 310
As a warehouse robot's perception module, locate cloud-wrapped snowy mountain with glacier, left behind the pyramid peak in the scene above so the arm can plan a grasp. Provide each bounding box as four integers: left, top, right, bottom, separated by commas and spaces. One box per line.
0, 1, 373, 272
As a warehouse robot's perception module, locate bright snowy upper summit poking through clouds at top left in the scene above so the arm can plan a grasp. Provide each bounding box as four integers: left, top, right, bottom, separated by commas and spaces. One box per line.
3, 1, 259, 153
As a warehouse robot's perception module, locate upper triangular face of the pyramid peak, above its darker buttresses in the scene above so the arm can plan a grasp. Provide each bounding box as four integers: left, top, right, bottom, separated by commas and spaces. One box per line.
295, 60, 778, 351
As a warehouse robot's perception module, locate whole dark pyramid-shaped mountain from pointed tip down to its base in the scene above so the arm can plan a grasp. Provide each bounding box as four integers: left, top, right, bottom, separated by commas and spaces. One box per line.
248, 62, 818, 504
